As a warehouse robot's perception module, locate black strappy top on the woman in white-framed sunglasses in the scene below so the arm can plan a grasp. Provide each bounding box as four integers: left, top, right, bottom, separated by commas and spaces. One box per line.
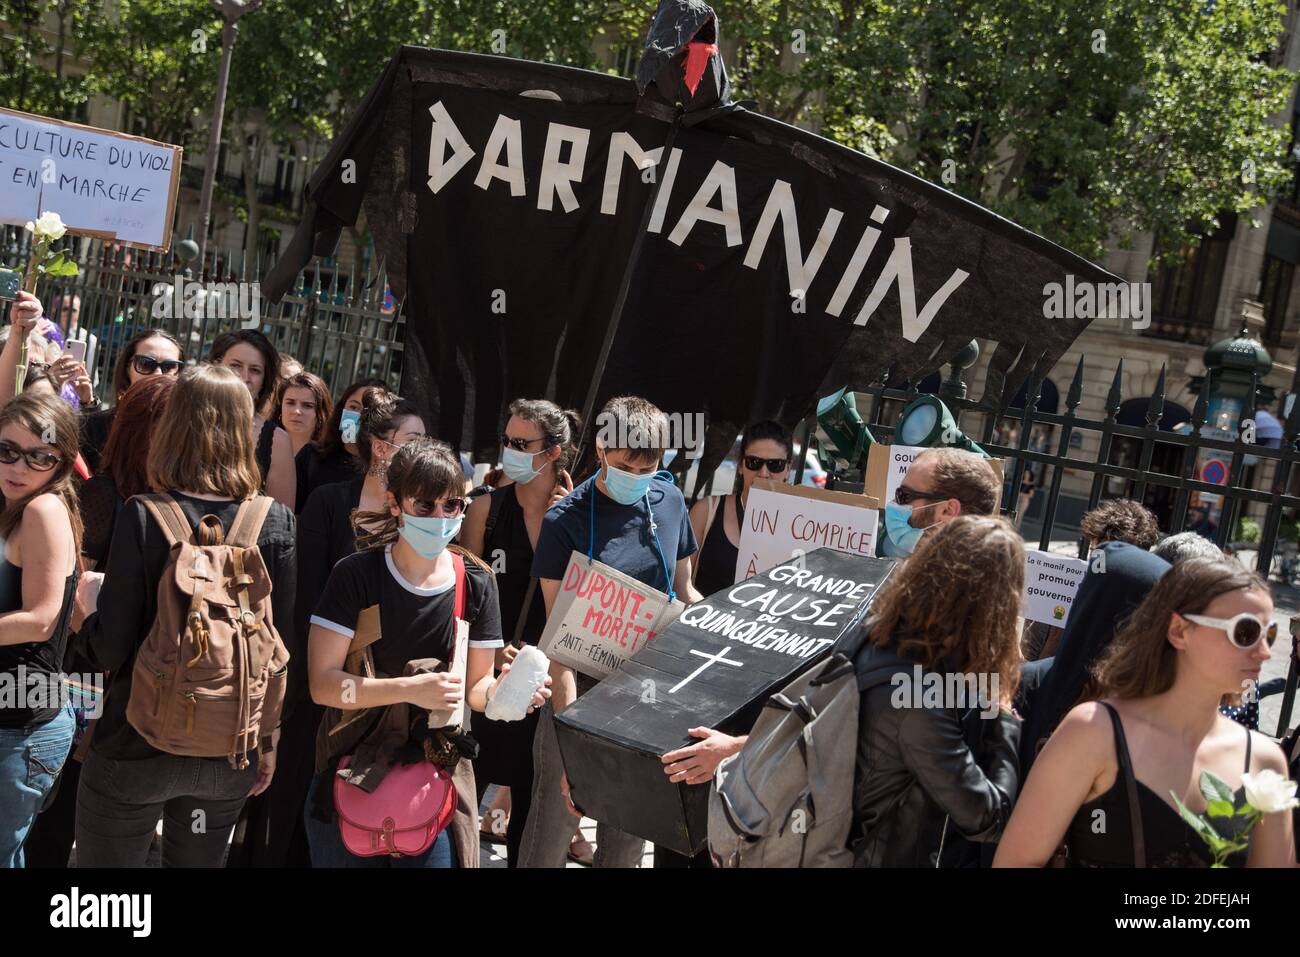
1066, 702, 1251, 867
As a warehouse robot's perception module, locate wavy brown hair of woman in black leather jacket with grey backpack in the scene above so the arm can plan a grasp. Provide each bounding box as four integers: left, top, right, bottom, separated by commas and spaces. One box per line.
868, 515, 1024, 694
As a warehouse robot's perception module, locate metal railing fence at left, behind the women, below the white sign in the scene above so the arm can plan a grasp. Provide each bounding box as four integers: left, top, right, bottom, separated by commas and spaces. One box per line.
0, 226, 404, 402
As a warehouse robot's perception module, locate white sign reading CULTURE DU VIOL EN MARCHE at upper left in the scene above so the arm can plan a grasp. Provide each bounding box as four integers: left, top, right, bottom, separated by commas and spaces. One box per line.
0, 108, 182, 251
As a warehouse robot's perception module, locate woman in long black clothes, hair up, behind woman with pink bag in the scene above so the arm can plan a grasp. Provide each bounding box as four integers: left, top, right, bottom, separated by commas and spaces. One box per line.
229, 386, 424, 867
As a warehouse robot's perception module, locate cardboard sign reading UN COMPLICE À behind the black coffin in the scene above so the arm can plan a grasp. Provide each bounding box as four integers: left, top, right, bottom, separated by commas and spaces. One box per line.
736, 479, 880, 581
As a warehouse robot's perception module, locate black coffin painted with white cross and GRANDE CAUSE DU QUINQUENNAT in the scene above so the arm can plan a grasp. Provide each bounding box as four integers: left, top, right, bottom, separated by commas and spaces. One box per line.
555, 549, 894, 854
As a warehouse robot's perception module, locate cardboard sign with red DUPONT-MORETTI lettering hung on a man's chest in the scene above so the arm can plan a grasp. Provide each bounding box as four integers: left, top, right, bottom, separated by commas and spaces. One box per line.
537, 551, 686, 679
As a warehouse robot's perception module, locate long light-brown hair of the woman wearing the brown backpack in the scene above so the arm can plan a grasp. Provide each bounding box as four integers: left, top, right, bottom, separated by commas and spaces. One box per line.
147, 364, 261, 499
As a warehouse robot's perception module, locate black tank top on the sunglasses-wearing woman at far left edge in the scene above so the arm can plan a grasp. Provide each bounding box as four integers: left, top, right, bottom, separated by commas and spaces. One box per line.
0, 553, 78, 728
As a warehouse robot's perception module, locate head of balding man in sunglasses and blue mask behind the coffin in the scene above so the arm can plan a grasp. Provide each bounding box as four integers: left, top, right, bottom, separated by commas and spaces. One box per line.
881, 449, 1001, 557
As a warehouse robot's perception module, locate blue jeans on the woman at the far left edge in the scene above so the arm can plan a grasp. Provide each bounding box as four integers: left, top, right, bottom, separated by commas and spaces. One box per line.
0, 703, 77, 867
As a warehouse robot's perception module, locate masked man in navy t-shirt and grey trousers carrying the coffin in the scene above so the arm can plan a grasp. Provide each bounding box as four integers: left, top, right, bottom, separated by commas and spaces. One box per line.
520, 395, 701, 867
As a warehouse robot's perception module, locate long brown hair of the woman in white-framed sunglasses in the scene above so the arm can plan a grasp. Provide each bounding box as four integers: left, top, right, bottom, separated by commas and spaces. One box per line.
1083, 558, 1269, 701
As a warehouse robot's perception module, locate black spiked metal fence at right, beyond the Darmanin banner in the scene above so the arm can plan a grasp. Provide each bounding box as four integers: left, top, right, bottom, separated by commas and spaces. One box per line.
821, 356, 1300, 736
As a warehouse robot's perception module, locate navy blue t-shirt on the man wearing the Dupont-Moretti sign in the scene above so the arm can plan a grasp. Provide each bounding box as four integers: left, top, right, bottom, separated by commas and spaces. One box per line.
533, 479, 697, 593
